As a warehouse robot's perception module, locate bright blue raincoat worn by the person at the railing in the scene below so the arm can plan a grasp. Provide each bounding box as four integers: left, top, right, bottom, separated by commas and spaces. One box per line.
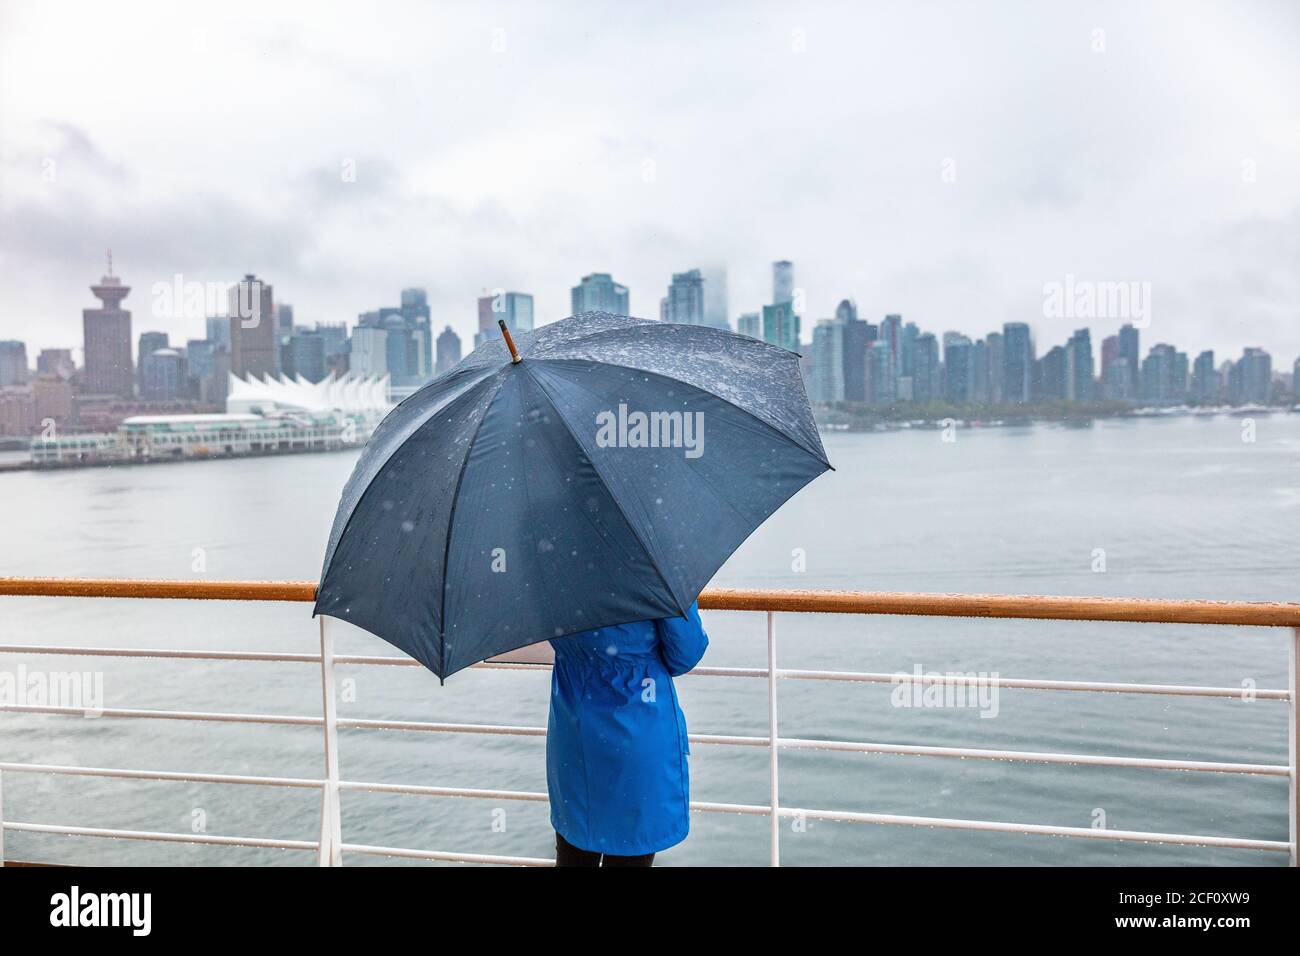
546, 605, 709, 856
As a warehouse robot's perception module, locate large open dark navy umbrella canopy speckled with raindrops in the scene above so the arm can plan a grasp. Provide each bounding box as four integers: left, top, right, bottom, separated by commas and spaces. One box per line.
315, 312, 831, 678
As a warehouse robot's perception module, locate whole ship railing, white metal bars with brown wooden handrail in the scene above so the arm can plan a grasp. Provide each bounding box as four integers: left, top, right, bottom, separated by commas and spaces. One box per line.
0, 578, 1300, 866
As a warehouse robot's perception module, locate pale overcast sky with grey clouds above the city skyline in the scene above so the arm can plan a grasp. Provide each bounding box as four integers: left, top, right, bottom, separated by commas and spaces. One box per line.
0, 0, 1300, 368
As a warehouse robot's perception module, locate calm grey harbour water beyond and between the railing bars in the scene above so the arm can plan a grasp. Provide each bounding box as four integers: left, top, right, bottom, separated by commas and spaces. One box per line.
0, 415, 1300, 865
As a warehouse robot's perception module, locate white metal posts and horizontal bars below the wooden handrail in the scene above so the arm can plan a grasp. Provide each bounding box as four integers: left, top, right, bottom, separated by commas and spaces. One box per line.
0, 610, 1300, 866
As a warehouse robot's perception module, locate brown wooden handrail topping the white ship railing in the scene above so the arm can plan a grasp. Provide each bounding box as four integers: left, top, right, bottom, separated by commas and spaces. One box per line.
0, 578, 1300, 627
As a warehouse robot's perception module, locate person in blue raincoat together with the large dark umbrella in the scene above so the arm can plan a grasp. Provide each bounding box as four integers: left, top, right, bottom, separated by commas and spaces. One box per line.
315, 312, 831, 866
